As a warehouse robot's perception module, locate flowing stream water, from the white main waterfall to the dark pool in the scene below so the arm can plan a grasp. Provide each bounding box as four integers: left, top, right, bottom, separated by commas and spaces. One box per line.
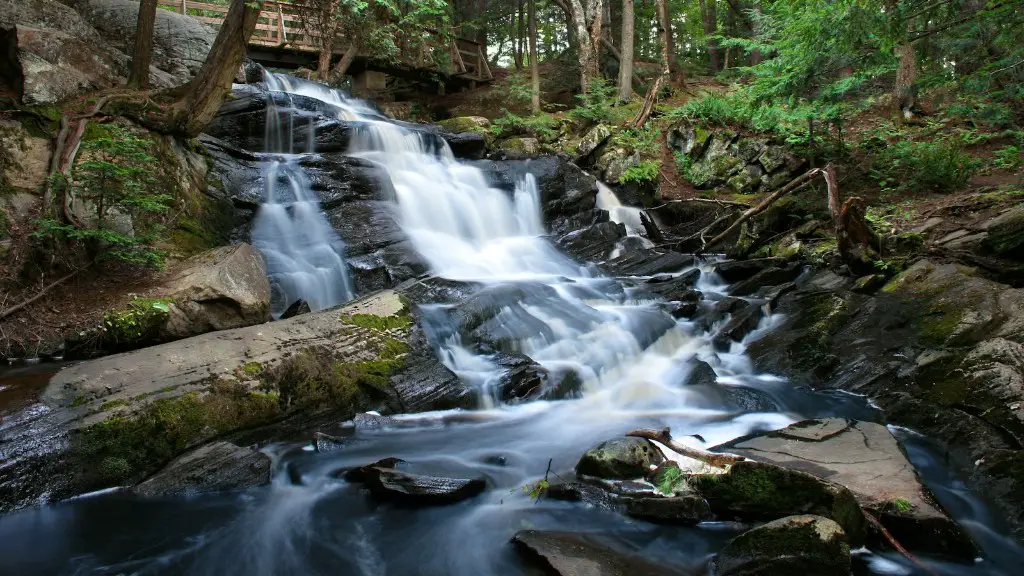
0, 77, 1016, 576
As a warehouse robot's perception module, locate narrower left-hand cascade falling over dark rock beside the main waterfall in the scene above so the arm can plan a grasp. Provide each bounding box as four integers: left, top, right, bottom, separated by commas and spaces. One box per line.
252, 74, 355, 318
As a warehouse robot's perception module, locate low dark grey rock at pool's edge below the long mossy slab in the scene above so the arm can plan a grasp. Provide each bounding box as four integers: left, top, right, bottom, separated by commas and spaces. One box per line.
134, 442, 270, 497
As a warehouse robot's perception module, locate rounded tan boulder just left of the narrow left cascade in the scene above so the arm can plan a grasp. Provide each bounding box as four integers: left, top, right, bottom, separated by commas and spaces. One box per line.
156, 244, 270, 338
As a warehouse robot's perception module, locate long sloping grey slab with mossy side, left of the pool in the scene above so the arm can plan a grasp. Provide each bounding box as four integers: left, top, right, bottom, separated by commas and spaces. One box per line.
0, 290, 474, 510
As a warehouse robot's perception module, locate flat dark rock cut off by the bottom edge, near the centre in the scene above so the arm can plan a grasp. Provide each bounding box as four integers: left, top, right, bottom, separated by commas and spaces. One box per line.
512, 530, 697, 576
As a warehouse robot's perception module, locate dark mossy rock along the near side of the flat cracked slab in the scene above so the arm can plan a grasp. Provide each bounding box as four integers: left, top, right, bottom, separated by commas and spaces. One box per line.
688, 461, 866, 545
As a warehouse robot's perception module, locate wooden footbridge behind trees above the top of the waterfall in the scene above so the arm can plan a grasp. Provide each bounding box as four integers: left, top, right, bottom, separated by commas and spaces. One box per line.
159, 0, 494, 90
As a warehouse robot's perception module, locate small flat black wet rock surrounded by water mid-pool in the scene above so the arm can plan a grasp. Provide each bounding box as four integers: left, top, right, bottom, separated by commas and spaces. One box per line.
364, 466, 486, 506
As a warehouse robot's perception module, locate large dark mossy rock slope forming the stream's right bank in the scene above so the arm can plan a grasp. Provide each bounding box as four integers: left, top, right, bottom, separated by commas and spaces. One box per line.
748, 260, 1024, 538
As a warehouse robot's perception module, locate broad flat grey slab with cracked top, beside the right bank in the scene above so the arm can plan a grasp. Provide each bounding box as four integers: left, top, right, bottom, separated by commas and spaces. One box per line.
723, 418, 977, 558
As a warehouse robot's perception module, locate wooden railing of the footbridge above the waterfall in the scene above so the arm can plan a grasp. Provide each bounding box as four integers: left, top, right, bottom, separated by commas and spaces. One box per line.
158, 0, 494, 81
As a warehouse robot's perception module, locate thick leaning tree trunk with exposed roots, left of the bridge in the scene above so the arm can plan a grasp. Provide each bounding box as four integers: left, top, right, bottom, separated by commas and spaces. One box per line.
172, 0, 263, 137
